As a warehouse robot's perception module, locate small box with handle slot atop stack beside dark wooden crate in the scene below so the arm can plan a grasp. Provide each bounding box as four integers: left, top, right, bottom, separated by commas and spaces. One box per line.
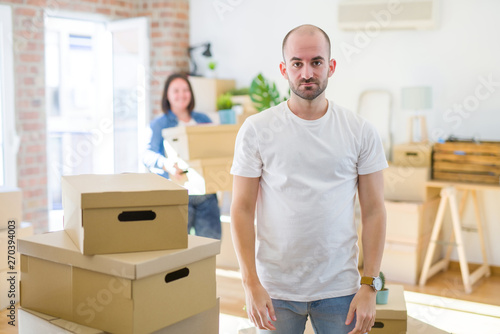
392, 143, 432, 167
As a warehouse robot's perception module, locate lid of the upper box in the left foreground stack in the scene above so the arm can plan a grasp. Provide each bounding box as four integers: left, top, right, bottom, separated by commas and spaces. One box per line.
62, 173, 189, 209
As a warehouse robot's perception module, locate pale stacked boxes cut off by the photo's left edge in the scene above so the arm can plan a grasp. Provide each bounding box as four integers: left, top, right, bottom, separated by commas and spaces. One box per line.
0, 187, 33, 310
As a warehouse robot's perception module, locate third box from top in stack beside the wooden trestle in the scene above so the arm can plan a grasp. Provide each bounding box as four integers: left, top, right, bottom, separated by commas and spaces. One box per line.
385, 198, 440, 243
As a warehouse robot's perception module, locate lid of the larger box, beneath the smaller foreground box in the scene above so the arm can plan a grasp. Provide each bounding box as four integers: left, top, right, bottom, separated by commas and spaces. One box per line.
18, 231, 220, 279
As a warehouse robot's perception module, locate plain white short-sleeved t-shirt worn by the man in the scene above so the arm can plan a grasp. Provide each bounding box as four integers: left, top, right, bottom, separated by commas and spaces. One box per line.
231, 101, 387, 302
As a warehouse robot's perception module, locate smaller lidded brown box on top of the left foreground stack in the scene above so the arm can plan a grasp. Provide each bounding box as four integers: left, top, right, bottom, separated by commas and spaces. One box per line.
62, 173, 188, 255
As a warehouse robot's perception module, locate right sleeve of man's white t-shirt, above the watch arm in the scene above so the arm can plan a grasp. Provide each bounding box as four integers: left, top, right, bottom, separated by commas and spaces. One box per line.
358, 122, 389, 175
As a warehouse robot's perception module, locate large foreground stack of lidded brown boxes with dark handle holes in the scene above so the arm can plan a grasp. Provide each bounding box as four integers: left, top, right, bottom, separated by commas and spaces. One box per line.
19, 174, 220, 334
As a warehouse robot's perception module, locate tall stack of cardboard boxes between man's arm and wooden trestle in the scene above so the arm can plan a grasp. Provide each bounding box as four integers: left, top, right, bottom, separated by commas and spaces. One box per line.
381, 143, 439, 284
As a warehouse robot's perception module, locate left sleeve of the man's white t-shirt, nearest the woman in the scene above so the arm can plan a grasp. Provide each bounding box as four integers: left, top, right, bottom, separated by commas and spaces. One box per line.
231, 120, 262, 177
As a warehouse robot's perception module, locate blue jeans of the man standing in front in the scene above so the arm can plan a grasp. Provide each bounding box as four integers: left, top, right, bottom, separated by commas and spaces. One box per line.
259, 295, 356, 334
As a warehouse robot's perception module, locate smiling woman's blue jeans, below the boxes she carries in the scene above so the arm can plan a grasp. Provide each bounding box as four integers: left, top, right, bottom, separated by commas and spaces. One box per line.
188, 194, 221, 239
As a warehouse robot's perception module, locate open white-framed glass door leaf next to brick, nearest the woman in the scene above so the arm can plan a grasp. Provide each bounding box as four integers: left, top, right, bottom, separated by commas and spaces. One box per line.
108, 17, 149, 173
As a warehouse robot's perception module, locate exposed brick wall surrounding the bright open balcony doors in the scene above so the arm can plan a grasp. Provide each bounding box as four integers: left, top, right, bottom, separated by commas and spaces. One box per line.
0, 0, 189, 232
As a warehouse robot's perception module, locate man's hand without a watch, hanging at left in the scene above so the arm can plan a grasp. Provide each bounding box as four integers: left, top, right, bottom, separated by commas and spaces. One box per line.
244, 283, 276, 331
